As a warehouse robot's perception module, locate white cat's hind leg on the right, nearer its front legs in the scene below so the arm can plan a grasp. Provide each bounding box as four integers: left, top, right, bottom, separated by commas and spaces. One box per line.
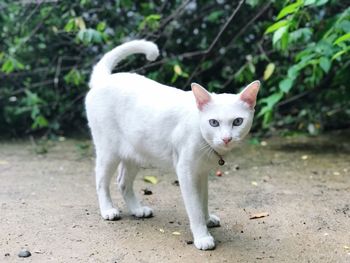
117, 162, 153, 218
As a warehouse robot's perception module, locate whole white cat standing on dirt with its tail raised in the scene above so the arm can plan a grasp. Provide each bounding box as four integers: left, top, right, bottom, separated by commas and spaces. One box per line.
86, 40, 260, 250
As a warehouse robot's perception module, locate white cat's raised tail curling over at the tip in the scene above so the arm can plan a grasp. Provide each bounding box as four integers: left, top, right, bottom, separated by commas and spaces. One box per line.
89, 40, 159, 88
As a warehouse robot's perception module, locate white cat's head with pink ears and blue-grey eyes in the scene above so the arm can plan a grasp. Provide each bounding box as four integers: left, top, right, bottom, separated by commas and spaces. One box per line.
191, 81, 260, 154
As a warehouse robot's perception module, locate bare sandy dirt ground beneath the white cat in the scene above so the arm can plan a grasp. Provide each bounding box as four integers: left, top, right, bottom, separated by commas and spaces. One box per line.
0, 131, 350, 263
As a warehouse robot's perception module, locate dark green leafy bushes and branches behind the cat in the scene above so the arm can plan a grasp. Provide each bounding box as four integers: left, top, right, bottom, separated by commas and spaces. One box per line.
0, 0, 350, 136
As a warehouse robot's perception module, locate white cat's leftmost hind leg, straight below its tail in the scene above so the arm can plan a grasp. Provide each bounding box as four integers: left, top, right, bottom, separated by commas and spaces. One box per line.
96, 151, 120, 220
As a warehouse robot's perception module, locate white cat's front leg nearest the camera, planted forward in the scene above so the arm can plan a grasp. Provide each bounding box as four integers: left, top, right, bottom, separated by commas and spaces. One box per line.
176, 161, 215, 250
